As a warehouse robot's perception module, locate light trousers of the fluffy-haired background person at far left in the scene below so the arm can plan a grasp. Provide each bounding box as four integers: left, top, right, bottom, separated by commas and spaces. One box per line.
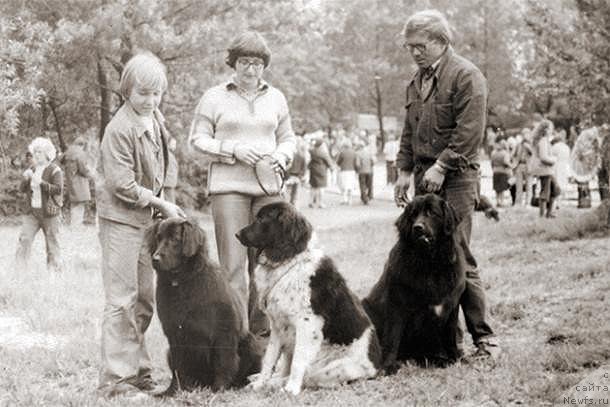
15, 208, 61, 271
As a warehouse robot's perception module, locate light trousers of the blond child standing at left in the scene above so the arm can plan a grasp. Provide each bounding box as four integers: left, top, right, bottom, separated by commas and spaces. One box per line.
99, 218, 155, 391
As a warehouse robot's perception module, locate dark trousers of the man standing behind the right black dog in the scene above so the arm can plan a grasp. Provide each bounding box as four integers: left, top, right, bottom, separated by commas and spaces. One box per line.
414, 165, 493, 344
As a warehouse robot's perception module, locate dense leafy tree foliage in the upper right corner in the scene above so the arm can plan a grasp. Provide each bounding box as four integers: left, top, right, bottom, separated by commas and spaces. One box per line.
527, 0, 610, 124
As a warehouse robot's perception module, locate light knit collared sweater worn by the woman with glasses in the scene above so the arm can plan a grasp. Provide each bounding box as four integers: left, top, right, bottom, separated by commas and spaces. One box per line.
189, 81, 296, 196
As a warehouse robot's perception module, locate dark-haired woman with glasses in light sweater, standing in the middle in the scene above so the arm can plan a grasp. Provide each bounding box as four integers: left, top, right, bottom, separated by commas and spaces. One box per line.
189, 31, 296, 333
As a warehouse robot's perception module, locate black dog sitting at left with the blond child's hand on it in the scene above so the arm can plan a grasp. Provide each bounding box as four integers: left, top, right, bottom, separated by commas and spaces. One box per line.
149, 218, 262, 396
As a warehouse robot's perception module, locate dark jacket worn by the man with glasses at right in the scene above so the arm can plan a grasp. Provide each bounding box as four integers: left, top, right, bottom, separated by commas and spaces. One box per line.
396, 46, 487, 172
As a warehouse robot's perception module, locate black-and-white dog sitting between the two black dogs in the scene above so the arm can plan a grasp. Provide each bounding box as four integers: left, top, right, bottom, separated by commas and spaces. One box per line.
237, 202, 381, 395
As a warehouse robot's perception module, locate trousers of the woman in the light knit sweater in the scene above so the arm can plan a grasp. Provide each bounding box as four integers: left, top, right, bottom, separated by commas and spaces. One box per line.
211, 193, 283, 328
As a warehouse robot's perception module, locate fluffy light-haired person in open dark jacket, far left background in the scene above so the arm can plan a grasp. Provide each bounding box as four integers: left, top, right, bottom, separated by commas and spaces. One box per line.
15, 137, 64, 272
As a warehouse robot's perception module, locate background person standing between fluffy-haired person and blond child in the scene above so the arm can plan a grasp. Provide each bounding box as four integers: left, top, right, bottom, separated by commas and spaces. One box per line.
60, 136, 94, 226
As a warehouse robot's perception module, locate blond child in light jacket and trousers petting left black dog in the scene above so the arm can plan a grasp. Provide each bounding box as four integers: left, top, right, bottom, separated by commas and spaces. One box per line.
96, 53, 185, 400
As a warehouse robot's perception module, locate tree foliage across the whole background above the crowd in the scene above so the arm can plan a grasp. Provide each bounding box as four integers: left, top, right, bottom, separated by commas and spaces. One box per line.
0, 0, 610, 214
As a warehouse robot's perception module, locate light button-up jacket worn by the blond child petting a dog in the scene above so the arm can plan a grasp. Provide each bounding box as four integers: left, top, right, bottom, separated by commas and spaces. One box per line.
96, 103, 168, 227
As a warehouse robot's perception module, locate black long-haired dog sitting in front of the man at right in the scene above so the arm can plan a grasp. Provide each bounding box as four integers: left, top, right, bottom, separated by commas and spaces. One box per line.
363, 194, 465, 373
